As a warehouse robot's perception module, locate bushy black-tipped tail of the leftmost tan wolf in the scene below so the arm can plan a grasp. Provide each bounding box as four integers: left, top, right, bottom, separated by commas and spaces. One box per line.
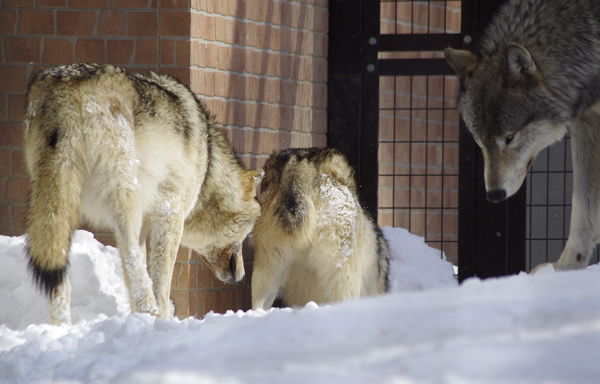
25, 117, 84, 297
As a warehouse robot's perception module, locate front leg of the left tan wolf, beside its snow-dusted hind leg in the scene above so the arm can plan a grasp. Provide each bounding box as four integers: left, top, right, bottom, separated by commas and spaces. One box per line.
149, 197, 184, 319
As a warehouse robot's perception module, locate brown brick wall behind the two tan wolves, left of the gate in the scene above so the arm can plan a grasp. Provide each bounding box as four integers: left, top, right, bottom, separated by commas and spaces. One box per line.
0, 0, 328, 316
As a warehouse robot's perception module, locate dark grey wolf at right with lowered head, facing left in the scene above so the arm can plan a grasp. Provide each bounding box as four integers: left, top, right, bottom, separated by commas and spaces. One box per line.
444, 0, 600, 270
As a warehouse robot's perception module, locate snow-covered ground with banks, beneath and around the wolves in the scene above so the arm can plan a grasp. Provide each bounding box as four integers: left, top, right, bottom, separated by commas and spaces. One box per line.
0, 228, 600, 384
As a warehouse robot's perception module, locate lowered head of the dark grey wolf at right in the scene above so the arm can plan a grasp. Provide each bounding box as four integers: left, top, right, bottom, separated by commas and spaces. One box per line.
444, 43, 572, 203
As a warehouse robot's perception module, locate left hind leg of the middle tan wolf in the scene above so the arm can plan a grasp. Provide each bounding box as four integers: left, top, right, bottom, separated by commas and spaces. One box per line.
252, 244, 286, 310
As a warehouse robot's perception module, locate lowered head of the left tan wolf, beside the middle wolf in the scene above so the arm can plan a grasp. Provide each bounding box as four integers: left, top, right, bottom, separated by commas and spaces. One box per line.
181, 170, 264, 284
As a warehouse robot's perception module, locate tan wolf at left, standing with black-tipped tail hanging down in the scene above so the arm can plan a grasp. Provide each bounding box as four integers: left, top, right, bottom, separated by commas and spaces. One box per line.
25, 64, 262, 323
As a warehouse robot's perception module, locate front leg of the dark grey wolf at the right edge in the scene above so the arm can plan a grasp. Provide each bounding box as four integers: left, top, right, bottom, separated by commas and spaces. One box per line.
554, 107, 600, 270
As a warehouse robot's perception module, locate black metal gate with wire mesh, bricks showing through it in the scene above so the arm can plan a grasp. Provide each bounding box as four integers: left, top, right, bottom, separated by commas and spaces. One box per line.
328, 0, 526, 280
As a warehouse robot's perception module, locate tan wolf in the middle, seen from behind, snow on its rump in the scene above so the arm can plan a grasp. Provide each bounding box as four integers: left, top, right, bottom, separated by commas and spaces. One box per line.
252, 149, 390, 309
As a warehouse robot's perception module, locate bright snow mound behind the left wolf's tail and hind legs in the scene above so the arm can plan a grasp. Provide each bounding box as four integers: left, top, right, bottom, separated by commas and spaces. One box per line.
0, 231, 129, 329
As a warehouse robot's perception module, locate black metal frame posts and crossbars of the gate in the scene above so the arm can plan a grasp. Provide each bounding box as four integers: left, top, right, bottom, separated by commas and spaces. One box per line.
328, 0, 526, 280
